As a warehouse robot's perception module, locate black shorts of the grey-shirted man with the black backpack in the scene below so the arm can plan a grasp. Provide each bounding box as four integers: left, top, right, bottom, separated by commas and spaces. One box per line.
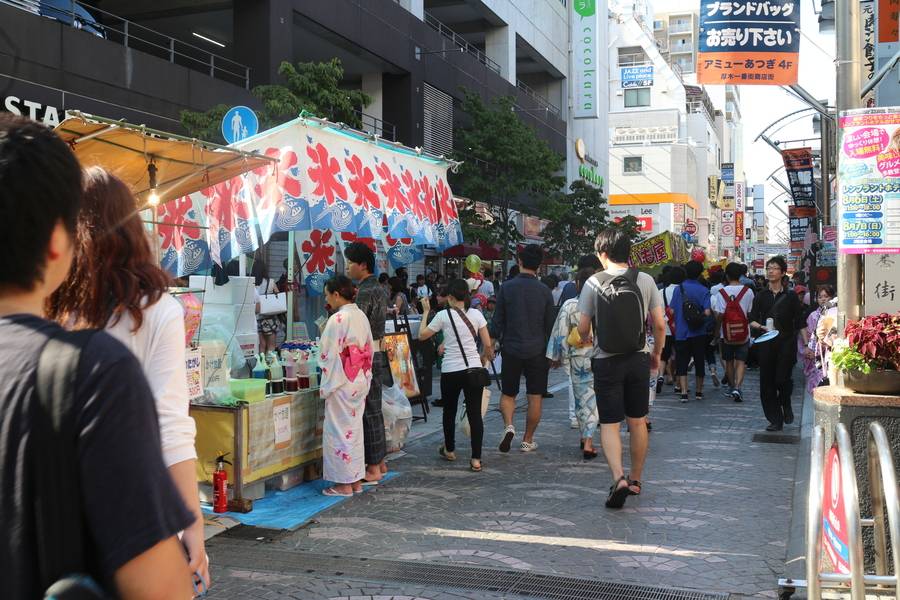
591, 352, 650, 424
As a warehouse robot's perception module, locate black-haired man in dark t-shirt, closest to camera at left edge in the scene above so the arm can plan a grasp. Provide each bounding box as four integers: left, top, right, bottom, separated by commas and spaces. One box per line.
0, 114, 194, 600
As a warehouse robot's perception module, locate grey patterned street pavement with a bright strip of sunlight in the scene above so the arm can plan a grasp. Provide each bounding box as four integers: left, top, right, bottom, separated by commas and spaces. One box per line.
208, 360, 805, 600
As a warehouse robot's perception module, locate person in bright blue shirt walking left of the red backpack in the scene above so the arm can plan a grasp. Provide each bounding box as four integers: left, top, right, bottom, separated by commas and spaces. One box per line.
670, 260, 712, 402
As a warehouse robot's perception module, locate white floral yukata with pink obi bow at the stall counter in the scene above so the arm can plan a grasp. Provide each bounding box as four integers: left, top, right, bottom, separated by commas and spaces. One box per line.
319, 304, 372, 483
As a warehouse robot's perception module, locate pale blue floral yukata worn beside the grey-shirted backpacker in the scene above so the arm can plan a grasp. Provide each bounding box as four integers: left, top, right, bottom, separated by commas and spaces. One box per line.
547, 298, 599, 438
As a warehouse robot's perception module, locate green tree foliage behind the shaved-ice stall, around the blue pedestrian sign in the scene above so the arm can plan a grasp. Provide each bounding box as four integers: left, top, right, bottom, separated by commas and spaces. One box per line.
181, 58, 372, 144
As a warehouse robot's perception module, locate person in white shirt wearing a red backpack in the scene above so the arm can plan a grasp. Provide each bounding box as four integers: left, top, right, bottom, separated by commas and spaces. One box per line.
711, 263, 754, 402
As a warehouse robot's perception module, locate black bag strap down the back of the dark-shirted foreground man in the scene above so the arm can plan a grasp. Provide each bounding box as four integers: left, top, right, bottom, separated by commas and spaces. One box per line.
34, 330, 109, 600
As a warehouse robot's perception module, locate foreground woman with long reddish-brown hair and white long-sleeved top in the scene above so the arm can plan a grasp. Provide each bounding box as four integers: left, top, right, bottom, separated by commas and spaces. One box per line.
47, 167, 210, 585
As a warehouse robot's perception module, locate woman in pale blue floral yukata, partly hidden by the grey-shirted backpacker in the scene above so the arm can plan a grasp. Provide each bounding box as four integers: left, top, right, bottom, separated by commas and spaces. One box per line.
547, 269, 599, 460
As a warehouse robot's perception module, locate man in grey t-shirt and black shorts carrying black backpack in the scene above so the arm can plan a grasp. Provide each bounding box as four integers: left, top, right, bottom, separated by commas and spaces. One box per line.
578, 228, 666, 508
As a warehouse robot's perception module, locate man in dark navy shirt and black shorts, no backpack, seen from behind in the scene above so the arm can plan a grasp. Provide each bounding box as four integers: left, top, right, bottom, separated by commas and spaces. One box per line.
491, 244, 556, 452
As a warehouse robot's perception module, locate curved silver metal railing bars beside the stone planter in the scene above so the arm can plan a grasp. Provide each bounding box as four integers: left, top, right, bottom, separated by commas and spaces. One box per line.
778, 421, 900, 600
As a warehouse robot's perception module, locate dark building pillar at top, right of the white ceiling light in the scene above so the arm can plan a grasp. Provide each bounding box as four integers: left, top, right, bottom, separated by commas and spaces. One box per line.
234, 0, 294, 86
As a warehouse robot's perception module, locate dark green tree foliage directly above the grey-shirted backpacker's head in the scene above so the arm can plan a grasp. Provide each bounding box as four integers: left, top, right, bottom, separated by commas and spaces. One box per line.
541, 180, 641, 264
